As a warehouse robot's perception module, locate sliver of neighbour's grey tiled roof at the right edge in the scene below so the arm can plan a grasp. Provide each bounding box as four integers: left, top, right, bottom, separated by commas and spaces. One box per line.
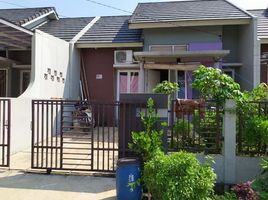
249, 9, 268, 38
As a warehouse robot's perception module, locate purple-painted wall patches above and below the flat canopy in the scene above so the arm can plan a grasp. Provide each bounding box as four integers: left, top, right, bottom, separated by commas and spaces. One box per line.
187, 42, 222, 99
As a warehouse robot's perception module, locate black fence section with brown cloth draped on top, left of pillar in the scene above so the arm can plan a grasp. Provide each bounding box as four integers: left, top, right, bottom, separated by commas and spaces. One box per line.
167, 100, 223, 154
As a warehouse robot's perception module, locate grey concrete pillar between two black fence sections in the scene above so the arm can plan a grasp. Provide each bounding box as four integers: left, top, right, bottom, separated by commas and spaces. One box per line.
223, 100, 236, 184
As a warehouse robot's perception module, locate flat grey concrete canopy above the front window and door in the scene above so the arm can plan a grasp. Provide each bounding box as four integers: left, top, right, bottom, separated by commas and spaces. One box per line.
134, 50, 230, 62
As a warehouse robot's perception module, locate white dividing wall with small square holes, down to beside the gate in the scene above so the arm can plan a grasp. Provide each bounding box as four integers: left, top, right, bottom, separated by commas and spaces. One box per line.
11, 30, 80, 154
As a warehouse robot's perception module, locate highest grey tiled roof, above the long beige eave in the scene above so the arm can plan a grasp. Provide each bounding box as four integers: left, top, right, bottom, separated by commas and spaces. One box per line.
129, 0, 251, 23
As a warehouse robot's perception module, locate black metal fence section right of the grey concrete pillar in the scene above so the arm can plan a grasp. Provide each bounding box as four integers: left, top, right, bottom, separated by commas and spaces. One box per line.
237, 101, 268, 156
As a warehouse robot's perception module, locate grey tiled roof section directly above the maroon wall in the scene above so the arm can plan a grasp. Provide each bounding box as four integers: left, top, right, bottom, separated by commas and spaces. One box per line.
77, 16, 142, 43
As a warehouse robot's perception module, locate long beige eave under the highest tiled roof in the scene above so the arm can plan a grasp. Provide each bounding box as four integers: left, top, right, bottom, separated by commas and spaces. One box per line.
129, 17, 251, 29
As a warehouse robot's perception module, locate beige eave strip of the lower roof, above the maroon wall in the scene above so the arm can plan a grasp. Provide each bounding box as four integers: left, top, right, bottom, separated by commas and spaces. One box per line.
75, 42, 143, 49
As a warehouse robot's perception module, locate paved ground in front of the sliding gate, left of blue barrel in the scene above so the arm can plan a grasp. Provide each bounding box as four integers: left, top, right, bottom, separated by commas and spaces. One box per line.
0, 150, 116, 200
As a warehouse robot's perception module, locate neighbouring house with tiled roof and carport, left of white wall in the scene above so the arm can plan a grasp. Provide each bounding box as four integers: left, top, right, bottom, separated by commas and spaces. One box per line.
0, 7, 58, 97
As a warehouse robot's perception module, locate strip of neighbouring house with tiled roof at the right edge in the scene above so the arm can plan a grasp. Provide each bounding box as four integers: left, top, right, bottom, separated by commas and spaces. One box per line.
249, 9, 268, 83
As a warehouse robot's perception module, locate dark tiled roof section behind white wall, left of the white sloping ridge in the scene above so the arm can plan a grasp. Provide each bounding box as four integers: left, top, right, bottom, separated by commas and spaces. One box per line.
38, 17, 93, 41
